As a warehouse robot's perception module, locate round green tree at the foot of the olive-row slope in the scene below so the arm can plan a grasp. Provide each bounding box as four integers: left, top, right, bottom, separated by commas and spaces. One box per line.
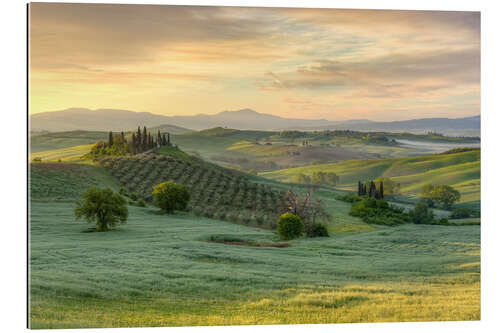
153, 181, 190, 213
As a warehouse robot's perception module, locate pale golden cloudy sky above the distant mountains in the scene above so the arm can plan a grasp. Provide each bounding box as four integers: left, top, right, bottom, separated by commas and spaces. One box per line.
29, 3, 480, 121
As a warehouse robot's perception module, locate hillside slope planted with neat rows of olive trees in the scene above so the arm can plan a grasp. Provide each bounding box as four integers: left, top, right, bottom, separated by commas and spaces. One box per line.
99, 154, 282, 228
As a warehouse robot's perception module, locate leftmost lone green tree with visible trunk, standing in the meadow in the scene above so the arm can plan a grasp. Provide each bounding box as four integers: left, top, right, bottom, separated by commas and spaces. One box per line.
75, 187, 128, 231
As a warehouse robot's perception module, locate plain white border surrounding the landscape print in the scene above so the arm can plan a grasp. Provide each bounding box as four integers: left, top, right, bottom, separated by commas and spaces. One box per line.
0, 0, 500, 333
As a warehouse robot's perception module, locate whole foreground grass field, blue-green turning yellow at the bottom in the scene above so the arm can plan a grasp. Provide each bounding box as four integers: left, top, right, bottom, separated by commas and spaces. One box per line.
30, 202, 480, 328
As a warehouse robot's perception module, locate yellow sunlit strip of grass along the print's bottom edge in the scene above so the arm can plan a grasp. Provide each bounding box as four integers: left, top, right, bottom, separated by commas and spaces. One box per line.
32, 282, 480, 328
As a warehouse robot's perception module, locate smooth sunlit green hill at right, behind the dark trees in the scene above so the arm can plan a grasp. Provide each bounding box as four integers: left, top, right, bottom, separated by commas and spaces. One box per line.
261, 149, 481, 202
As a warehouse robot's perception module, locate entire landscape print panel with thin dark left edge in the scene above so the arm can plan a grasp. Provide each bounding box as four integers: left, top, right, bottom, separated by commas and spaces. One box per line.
28, 3, 481, 329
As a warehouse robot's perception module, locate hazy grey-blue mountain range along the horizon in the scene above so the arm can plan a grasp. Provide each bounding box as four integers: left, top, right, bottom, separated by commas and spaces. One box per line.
30, 108, 481, 136
